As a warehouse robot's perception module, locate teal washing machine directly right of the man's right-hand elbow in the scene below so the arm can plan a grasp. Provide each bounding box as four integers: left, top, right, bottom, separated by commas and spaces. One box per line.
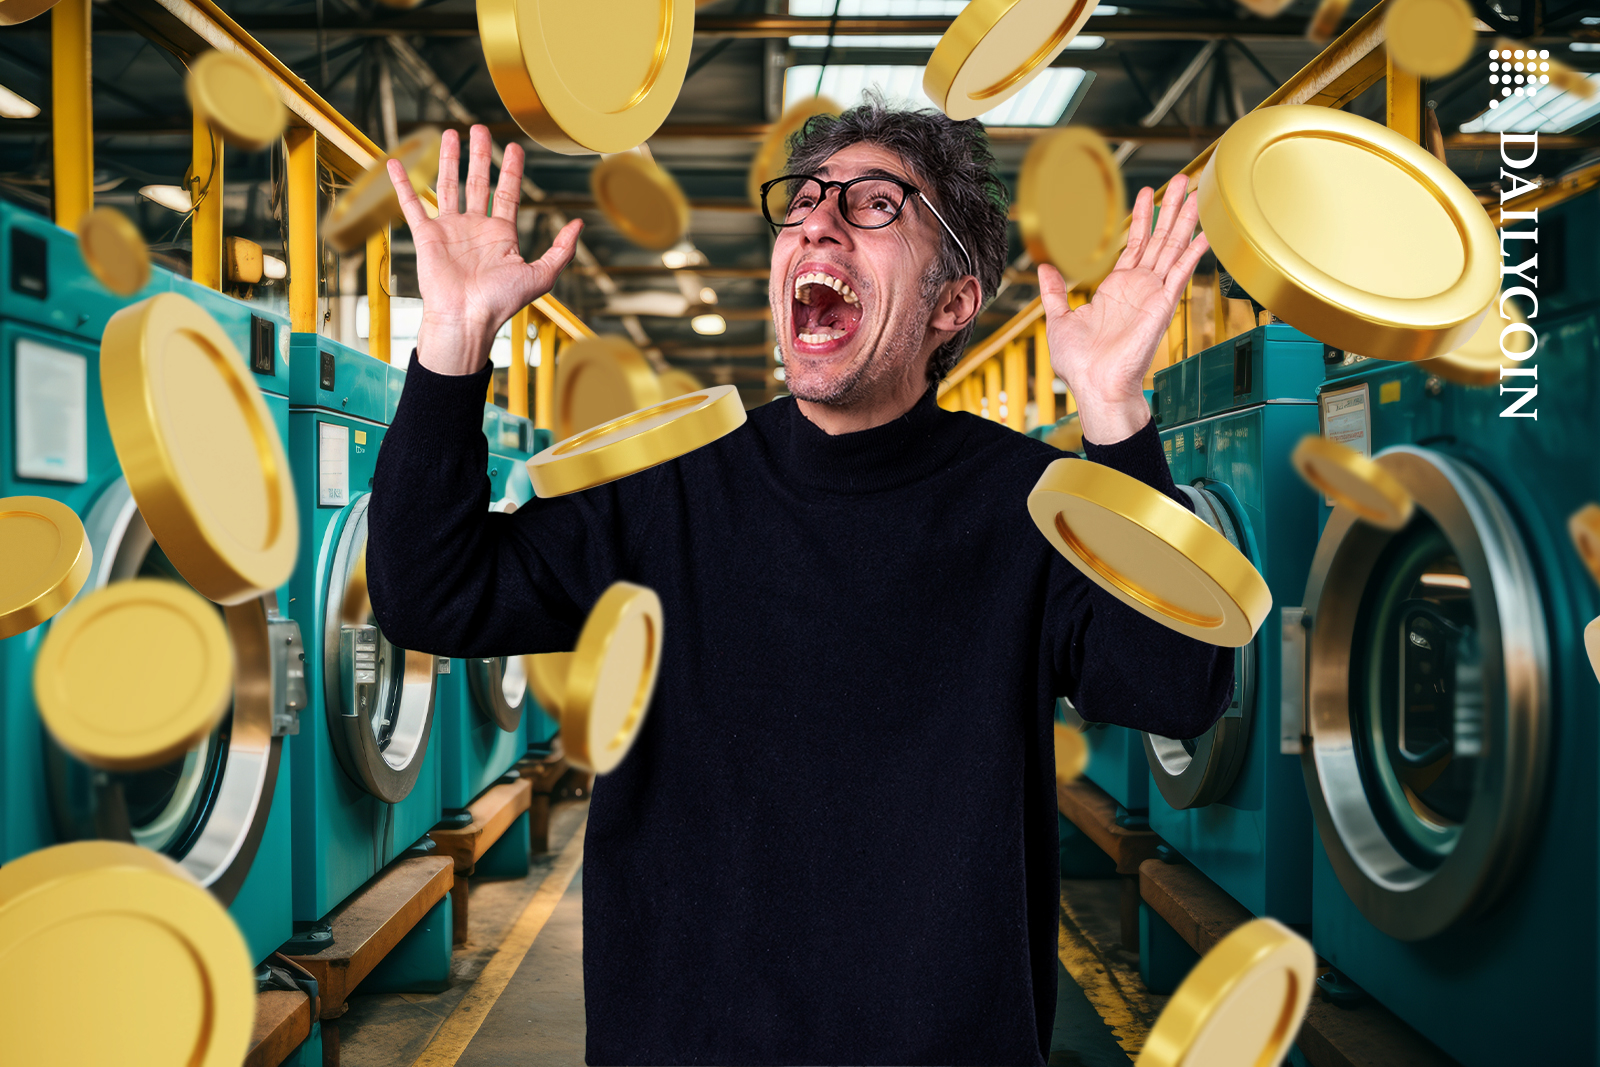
1141, 325, 1323, 923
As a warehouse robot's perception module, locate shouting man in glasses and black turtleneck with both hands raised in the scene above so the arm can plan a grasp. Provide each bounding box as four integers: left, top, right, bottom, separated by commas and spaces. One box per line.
368, 104, 1232, 1067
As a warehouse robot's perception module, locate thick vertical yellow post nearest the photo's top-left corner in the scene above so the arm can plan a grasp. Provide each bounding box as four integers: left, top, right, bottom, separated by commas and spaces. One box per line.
50, 0, 94, 230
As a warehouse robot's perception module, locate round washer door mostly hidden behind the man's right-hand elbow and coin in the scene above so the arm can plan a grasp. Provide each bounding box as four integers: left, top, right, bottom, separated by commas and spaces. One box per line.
1144, 485, 1259, 811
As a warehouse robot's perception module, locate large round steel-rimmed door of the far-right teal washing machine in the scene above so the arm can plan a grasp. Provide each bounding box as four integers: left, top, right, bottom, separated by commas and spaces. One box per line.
1283, 446, 1550, 941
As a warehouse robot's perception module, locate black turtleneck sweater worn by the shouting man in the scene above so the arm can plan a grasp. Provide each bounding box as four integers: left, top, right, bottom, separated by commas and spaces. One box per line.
366, 360, 1232, 1067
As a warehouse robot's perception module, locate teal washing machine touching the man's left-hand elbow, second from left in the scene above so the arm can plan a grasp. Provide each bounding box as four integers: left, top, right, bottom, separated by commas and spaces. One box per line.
288, 334, 443, 927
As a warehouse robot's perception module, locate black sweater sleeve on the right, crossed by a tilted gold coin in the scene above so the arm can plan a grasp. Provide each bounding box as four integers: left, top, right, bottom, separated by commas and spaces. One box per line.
1045, 421, 1234, 737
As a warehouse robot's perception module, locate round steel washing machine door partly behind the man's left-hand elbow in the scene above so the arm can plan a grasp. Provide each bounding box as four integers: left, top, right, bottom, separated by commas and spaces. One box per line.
322, 494, 437, 805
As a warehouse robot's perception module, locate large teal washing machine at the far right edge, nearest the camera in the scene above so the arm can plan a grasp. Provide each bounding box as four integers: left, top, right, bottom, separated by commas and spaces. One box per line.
1283, 192, 1600, 1067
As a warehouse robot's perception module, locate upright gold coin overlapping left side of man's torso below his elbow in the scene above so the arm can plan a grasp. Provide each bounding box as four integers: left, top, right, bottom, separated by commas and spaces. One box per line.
562, 582, 661, 774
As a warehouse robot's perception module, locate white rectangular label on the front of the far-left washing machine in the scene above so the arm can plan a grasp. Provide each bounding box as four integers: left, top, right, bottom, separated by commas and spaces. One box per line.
14, 338, 90, 485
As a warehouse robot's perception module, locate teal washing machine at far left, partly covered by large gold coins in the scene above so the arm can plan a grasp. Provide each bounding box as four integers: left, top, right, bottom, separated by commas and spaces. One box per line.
0, 208, 304, 960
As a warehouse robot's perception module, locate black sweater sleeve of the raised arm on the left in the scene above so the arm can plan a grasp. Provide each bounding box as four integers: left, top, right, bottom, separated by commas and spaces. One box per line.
366, 360, 654, 657
